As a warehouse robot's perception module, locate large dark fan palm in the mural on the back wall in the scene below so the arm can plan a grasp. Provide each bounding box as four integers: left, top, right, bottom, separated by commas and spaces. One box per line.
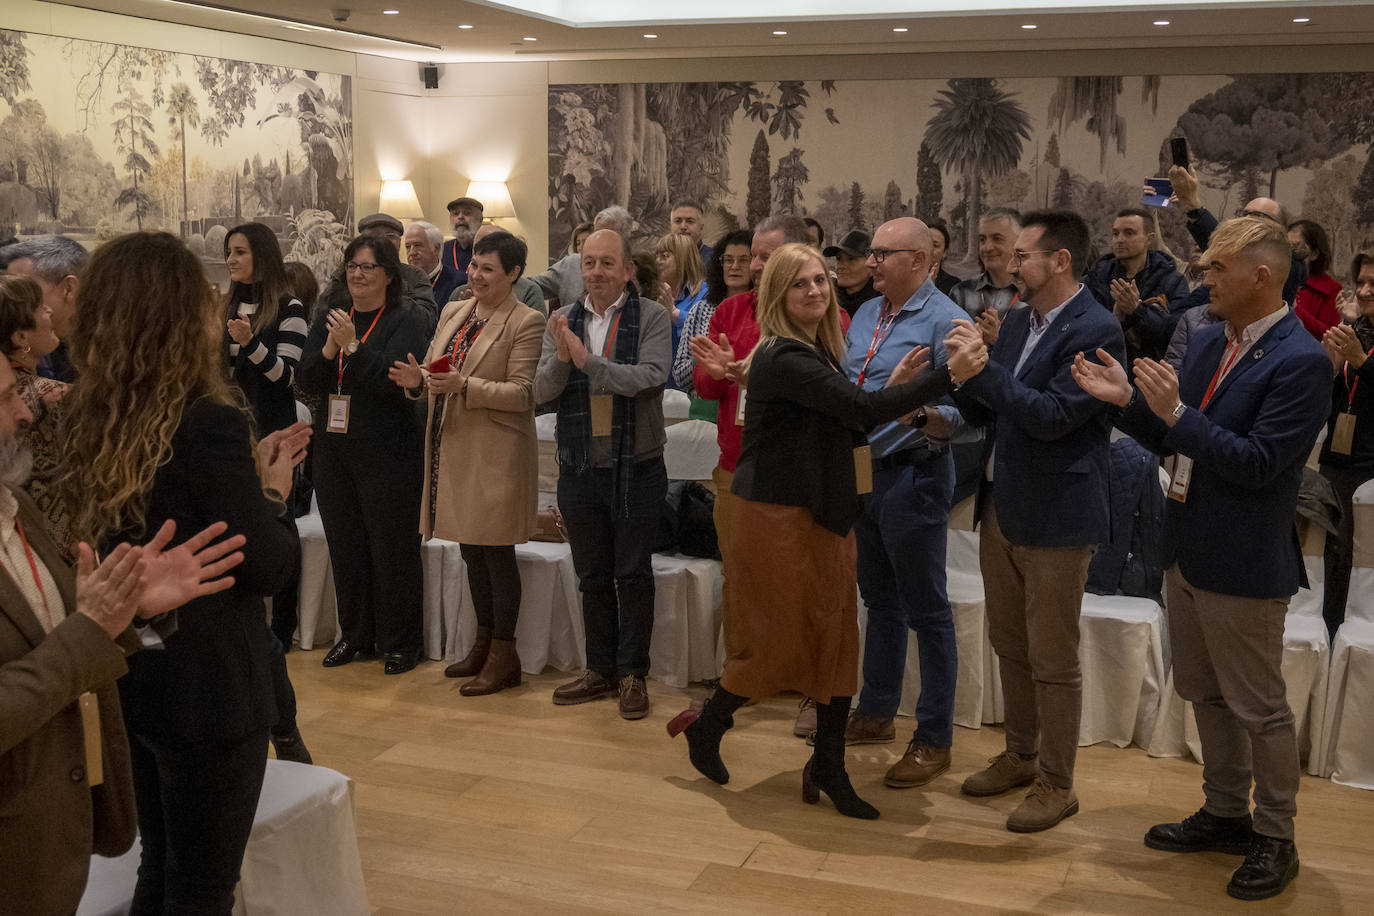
925, 77, 1031, 251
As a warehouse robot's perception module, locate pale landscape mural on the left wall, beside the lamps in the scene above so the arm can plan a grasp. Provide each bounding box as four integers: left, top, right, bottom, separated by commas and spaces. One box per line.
0, 30, 353, 282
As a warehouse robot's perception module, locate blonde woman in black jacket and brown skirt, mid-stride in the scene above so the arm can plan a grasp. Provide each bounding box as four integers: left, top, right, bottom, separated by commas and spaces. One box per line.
668, 243, 988, 818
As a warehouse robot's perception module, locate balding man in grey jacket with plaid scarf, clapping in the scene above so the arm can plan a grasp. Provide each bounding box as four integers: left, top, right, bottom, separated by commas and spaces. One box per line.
534, 229, 673, 720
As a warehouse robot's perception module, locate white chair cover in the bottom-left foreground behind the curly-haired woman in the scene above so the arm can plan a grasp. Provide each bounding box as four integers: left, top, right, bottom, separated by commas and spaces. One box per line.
77, 759, 368, 916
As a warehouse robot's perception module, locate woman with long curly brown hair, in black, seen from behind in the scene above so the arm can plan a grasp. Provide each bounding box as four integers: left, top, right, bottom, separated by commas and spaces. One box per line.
58, 232, 309, 915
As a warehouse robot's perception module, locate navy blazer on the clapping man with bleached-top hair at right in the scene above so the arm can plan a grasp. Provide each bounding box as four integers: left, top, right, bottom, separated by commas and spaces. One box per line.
1117, 310, 1331, 599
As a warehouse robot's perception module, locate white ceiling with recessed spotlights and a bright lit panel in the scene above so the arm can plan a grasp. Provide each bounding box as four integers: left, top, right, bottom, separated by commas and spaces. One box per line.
48, 0, 1374, 62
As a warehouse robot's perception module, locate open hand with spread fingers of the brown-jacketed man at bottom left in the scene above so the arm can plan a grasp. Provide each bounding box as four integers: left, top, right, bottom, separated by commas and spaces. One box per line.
136, 520, 246, 618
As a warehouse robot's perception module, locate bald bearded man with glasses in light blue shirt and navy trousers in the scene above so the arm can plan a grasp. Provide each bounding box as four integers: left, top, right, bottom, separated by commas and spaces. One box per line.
845, 217, 981, 788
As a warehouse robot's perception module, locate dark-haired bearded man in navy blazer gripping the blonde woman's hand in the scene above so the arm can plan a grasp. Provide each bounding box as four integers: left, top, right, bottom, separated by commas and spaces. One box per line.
956, 210, 1125, 832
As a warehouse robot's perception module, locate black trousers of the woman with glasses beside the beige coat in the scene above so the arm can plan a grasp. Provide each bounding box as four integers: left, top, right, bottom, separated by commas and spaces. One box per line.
313, 433, 425, 652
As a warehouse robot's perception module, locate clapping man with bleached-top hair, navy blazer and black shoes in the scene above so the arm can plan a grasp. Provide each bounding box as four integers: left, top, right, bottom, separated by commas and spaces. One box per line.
1074, 217, 1331, 900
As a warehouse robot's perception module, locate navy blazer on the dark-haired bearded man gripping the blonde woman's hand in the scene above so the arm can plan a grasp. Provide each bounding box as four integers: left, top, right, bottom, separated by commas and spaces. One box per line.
955, 287, 1125, 547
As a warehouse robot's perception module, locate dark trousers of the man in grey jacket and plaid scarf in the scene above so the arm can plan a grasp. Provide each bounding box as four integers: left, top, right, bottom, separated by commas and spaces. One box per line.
558, 456, 668, 677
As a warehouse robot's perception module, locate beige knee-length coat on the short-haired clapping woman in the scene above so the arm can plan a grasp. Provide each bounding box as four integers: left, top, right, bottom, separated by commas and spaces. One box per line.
420, 295, 545, 545
